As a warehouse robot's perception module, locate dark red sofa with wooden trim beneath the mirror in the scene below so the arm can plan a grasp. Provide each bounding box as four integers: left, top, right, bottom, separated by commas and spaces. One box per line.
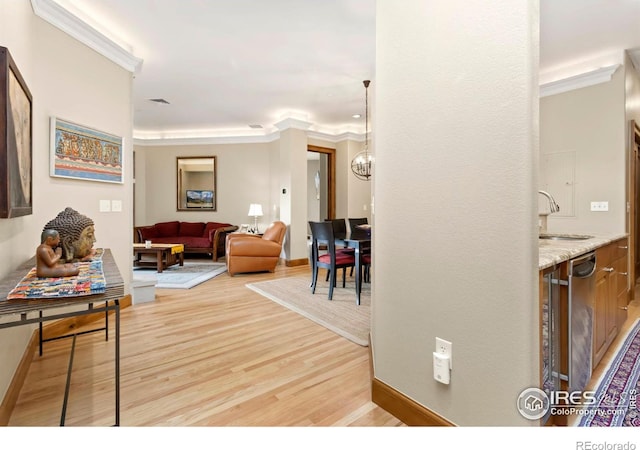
133, 220, 238, 261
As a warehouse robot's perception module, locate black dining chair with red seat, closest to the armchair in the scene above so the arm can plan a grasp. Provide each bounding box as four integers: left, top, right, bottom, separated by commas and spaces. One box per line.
309, 221, 356, 300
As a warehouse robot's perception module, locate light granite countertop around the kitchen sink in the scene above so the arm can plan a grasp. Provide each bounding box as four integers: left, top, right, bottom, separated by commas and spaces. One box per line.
538, 233, 628, 270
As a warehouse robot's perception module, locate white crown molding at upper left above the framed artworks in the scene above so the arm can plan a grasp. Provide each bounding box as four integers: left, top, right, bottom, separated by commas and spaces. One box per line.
31, 0, 142, 73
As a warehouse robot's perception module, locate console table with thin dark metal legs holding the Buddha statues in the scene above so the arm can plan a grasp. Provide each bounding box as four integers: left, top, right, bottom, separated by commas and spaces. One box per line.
0, 249, 124, 426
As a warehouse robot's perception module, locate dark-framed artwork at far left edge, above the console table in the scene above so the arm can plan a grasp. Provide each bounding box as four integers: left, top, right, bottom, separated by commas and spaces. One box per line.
0, 47, 33, 218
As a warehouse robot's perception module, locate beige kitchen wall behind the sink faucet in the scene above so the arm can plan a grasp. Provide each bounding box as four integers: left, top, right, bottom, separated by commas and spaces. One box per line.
540, 67, 627, 233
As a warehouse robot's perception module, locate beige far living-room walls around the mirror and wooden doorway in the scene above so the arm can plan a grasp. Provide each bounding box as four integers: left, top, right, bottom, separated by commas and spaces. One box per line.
135, 134, 371, 259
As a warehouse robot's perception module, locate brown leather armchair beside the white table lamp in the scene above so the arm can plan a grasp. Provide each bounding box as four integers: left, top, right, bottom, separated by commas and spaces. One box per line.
226, 221, 287, 276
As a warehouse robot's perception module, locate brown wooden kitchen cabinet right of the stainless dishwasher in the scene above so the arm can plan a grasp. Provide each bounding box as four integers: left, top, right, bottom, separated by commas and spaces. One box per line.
593, 238, 629, 368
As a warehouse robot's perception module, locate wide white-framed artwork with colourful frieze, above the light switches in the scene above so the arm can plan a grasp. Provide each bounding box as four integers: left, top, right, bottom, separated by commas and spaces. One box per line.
50, 117, 124, 183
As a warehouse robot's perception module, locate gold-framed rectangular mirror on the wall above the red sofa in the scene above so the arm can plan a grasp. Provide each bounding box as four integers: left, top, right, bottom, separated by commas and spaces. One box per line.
176, 156, 218, 211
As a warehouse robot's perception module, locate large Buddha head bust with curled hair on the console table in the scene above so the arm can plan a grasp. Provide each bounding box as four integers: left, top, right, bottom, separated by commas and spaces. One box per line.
44, 207, 96, 262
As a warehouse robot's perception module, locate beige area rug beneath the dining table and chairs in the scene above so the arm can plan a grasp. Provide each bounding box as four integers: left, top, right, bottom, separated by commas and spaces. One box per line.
247, 272, 371, 347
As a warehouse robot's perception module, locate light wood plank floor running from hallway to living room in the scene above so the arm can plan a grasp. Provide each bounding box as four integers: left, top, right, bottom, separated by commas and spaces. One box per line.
9, 260, 403, 426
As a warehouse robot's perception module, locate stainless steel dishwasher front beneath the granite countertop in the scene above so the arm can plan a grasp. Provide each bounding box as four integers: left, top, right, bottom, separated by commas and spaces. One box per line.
567, 252, 596, 392
